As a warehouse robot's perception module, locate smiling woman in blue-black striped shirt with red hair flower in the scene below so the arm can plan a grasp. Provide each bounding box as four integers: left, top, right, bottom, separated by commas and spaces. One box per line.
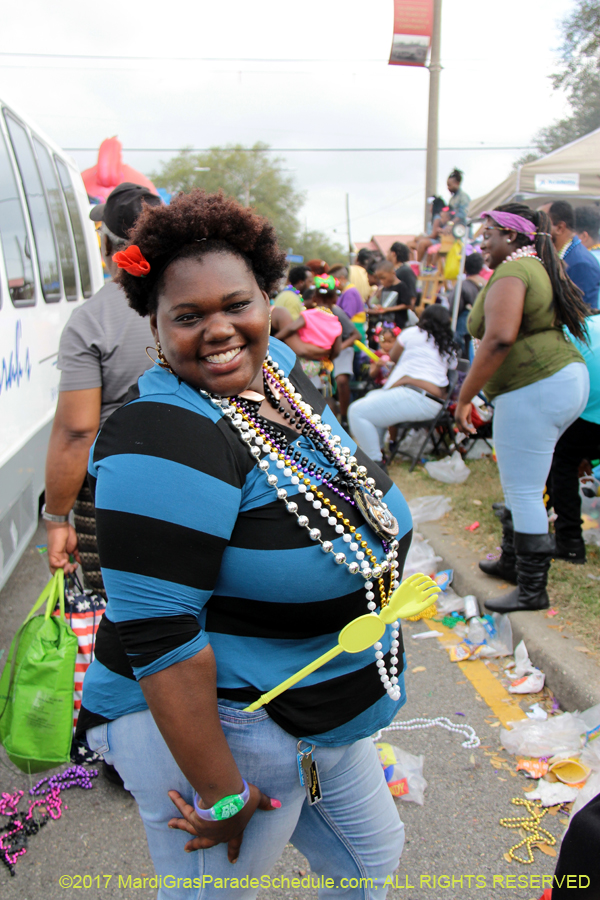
79, 192, 411, 900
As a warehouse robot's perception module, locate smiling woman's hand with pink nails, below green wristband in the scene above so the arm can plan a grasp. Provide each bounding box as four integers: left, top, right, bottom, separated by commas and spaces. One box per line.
169, 784, 281, 863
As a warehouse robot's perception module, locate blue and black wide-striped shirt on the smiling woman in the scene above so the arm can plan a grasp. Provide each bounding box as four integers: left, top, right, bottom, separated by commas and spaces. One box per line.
80, 339, 411, 745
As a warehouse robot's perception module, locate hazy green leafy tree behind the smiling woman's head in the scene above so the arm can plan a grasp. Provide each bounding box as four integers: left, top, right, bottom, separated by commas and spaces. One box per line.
150, 141, 344, 262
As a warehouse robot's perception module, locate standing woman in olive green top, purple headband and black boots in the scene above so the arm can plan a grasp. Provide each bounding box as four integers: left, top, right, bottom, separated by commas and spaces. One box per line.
455, 203, 589, 612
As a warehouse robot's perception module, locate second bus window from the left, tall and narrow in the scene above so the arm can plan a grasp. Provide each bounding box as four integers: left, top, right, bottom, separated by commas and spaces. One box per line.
4, 110, 62, 303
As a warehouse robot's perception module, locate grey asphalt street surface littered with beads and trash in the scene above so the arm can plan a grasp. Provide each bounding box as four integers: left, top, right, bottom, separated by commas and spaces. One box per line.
0, 527, 566, 900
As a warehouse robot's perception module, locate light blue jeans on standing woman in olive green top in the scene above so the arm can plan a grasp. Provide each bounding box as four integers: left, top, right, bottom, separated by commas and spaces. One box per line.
494, 363, 590, 534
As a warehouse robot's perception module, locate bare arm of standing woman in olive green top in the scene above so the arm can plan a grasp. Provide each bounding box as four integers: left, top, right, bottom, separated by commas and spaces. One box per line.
454, 275, 527, 434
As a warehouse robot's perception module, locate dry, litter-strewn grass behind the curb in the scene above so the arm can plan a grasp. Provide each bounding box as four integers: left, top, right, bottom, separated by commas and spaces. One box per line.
390, 457, 600, 651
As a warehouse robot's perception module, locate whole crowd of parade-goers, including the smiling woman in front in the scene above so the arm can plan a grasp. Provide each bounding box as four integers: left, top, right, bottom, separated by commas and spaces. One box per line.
39, 170, 600, 900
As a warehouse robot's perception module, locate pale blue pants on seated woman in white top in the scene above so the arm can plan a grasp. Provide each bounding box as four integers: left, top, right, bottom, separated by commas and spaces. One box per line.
348, 387, 442, 460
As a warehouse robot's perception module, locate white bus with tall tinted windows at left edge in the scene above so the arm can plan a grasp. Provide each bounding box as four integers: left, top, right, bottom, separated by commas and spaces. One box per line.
0, 101, 103, 588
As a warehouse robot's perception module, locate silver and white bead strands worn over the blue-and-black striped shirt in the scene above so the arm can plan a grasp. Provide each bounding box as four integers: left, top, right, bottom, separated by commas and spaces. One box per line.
200, 356, 400, 702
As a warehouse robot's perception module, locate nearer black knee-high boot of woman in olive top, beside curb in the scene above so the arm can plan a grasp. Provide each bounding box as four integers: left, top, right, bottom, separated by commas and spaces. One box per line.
485, 531, 554, 613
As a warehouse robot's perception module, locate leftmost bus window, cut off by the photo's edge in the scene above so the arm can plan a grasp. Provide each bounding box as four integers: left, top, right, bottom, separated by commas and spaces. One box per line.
0, 125, 35, 306
